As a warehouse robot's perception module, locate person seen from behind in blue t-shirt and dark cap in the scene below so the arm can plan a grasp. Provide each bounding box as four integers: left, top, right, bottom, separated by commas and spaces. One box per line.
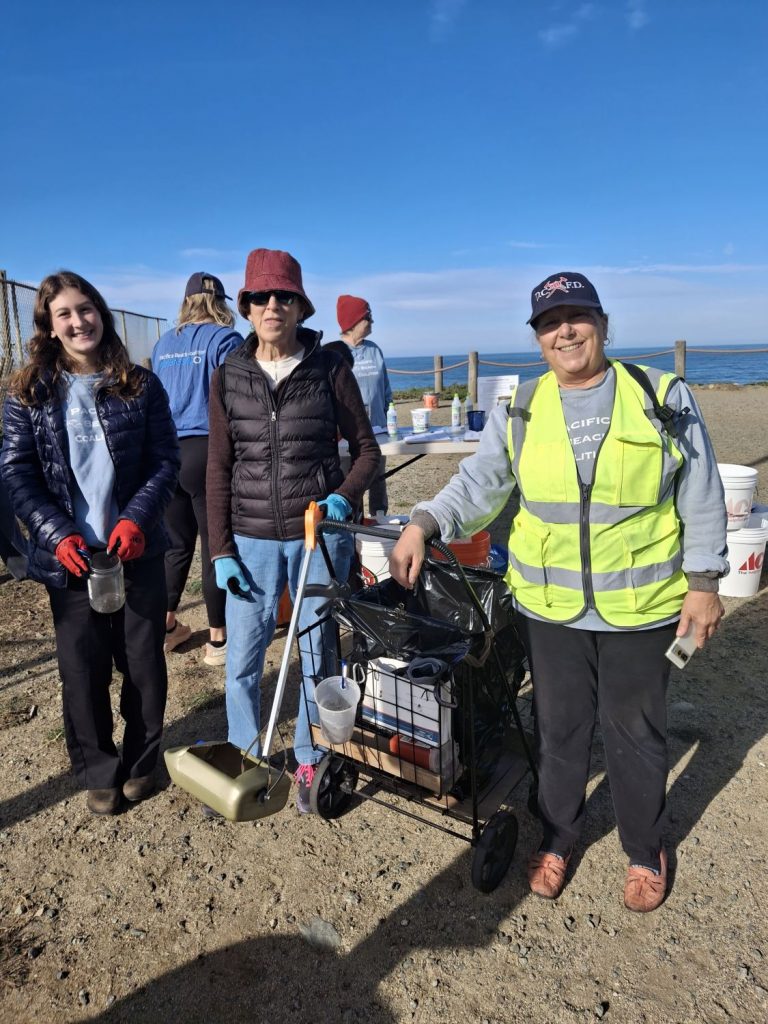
152, 271, 243, 666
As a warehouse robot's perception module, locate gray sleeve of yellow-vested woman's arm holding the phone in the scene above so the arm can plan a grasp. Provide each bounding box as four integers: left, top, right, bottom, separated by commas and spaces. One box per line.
667, 381, 728, 577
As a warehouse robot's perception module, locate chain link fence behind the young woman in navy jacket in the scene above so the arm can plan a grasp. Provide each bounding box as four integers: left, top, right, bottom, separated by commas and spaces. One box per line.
0, 270, 168, 380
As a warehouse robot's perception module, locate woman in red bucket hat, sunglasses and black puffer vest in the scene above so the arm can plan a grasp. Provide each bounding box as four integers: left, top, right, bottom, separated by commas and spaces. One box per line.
207, 249, 379, 813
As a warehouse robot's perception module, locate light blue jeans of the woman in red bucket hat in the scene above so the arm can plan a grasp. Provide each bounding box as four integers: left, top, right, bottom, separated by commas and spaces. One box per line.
226, 532, 354, 764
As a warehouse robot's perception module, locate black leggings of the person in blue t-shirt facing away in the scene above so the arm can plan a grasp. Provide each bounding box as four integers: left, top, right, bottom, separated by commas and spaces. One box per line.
165, 437, 226, 629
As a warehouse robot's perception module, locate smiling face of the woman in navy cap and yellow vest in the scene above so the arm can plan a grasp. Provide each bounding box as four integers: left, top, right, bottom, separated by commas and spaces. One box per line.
535, 306, 608, 387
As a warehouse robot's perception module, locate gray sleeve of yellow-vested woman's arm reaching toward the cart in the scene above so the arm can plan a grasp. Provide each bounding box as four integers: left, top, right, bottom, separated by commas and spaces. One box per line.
413, 406, 517, 543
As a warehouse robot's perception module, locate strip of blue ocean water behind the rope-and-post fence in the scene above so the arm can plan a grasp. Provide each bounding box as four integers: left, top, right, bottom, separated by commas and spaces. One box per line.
385, 343, 768, 391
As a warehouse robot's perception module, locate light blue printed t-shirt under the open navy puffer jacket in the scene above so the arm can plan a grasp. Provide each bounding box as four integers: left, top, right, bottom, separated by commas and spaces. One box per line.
58, 373, 120, 547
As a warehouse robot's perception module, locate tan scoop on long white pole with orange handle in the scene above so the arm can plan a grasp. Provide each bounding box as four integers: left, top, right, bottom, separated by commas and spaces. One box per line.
165, 502, 323, 821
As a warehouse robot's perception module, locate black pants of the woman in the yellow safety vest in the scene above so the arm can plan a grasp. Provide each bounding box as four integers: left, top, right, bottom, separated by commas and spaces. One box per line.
518, 615, 677, 867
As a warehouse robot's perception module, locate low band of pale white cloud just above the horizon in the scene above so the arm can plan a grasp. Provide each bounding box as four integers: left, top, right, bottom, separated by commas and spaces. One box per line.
89, 256, 768, 358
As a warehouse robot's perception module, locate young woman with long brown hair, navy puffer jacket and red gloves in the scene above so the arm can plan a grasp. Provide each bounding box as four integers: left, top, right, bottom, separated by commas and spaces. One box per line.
1, 270, 180, 814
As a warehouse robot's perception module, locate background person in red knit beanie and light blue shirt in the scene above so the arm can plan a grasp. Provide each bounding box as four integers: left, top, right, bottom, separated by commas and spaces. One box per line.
336, 295, 392, 516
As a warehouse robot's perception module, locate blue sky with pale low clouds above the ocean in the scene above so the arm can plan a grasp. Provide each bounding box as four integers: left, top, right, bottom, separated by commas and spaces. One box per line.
0, 0, 768, 355
